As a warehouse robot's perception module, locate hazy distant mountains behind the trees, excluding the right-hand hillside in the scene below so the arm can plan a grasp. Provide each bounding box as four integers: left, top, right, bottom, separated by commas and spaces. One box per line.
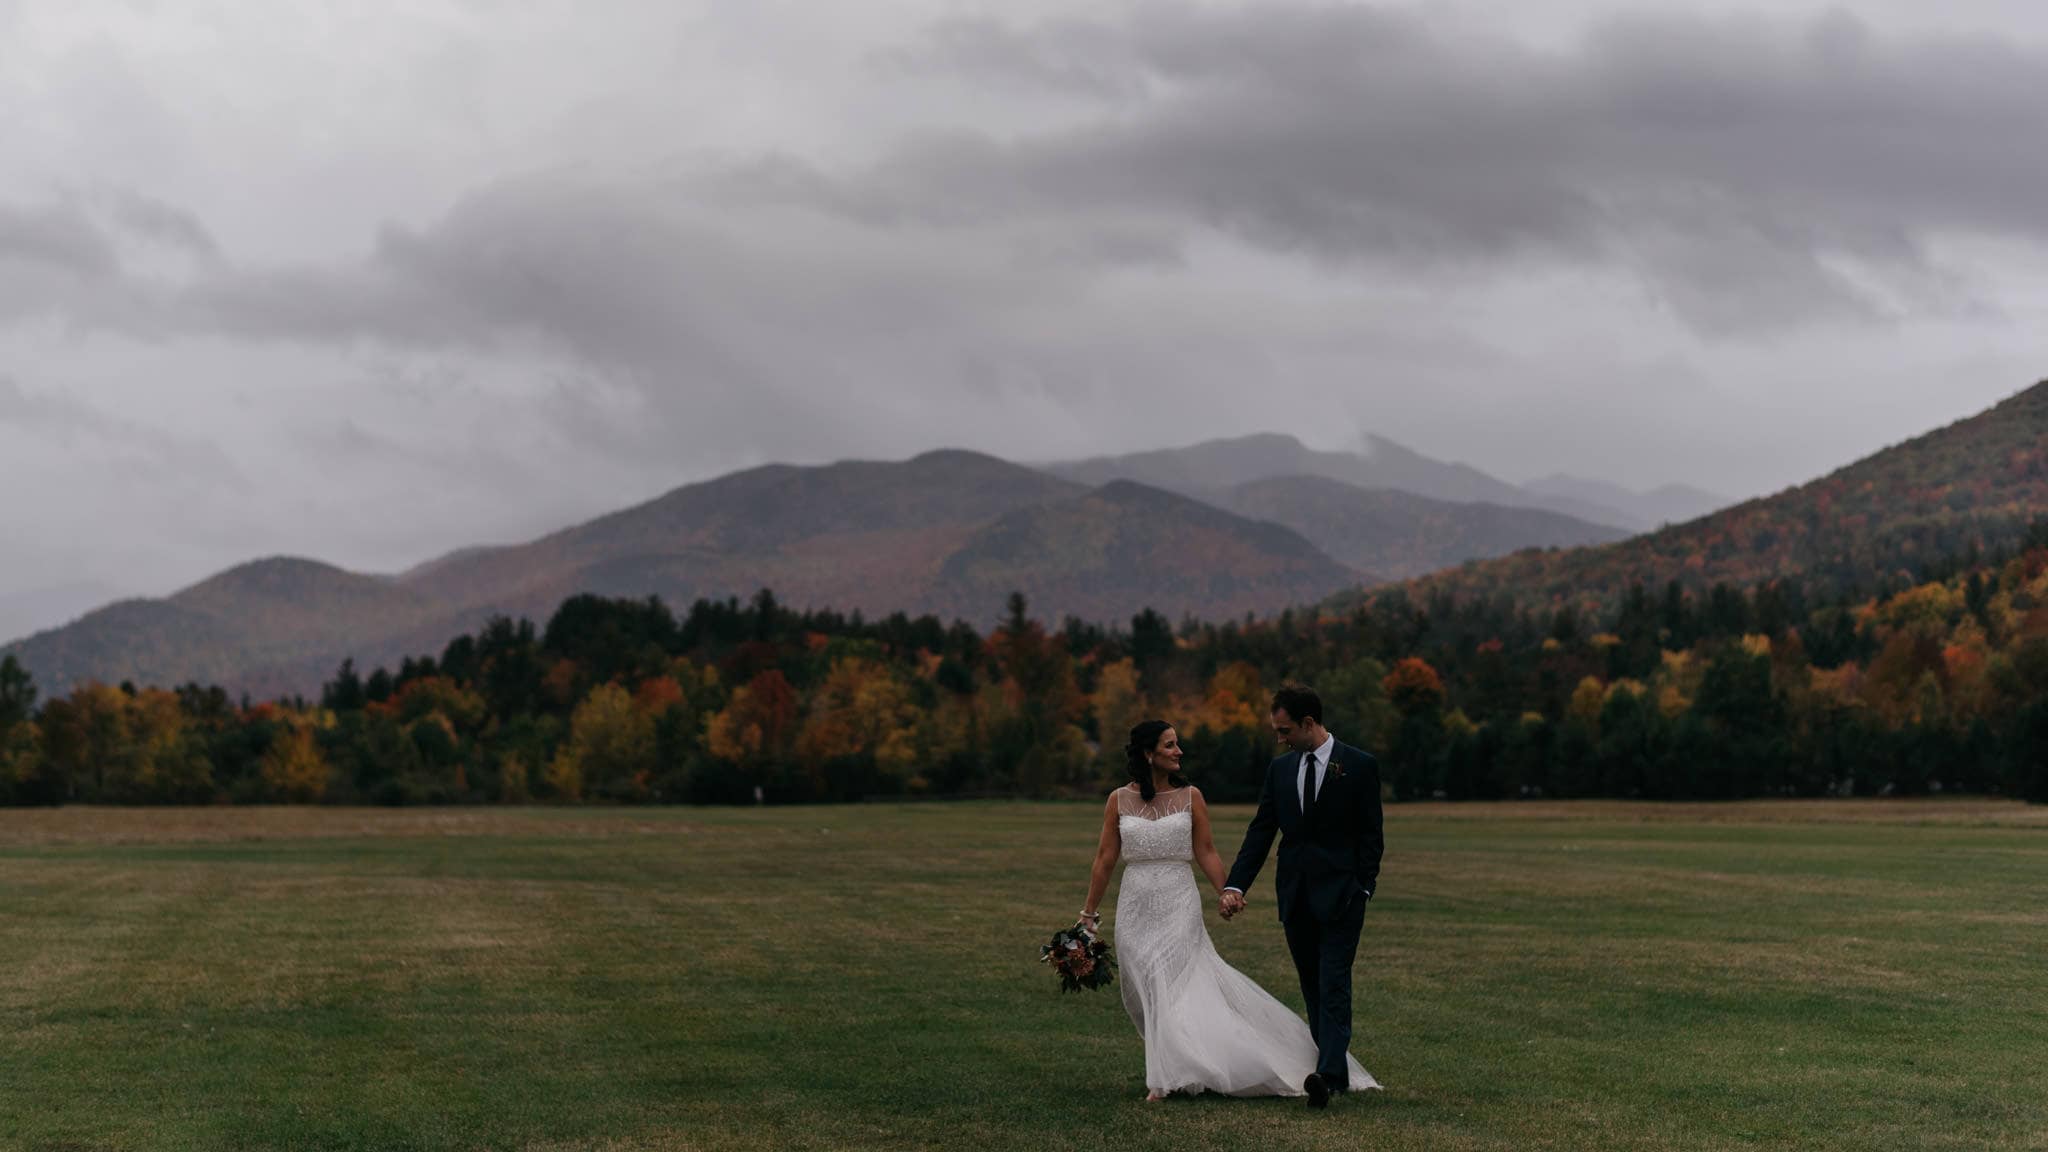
8, 435, 1662, 695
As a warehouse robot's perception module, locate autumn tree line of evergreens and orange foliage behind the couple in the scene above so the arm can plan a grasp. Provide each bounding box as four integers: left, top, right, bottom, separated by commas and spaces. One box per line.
0, 527, 2048, 806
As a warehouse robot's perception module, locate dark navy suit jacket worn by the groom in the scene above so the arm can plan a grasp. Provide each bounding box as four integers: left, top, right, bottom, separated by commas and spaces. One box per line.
1225, 742, 1386, 922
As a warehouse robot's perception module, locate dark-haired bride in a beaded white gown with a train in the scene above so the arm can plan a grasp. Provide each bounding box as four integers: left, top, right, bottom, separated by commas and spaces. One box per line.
1081, 719, 1378, 1101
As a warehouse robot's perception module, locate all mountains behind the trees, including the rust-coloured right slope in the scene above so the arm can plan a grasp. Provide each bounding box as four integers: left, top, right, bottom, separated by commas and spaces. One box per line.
6, 383, 2048, 695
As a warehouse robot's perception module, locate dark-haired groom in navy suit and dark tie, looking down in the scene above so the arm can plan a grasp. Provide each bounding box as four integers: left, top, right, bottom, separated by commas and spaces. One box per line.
1223, 687, 1386, 1109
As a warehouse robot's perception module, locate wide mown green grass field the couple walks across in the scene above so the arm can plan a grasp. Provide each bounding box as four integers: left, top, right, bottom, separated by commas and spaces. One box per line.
0, 801, 2048, 1150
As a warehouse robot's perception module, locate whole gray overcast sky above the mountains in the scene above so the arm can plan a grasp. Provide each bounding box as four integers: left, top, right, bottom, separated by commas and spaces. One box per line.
0, 0, 2048, 592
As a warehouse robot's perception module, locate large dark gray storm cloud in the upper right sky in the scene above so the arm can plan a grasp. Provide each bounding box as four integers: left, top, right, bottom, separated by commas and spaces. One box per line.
864, 6, 2048, 332
